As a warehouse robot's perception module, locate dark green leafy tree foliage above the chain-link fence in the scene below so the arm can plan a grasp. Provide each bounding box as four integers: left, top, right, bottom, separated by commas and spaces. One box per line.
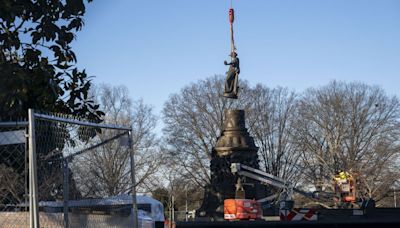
0, 0, 104, 121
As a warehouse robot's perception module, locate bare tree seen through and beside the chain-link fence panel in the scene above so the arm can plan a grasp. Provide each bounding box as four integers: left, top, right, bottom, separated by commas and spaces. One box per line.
74, 85, 162, 197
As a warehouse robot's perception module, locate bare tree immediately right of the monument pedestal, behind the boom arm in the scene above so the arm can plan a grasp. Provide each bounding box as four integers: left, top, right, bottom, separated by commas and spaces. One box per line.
246, 84, 300, 184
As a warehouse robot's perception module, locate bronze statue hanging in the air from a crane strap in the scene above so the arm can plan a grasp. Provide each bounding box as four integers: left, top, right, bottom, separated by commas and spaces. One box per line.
223, 51, 240, 99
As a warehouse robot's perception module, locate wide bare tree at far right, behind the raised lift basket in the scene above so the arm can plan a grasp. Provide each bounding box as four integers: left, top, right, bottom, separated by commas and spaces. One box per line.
293, 81, 400, 205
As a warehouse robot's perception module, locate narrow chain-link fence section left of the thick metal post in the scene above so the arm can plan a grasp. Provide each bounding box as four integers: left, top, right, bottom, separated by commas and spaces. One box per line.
0, 121, 29, 227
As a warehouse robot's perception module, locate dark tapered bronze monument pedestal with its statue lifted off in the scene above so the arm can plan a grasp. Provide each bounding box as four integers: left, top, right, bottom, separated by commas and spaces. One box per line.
196, 110, 266, 220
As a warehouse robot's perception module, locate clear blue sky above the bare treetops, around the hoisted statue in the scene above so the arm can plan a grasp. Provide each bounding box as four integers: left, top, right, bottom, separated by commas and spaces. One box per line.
73, 0, 400, 116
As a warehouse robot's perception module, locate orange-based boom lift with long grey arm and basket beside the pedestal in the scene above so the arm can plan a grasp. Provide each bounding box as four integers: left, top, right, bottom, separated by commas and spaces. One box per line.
224, 163, 356, 220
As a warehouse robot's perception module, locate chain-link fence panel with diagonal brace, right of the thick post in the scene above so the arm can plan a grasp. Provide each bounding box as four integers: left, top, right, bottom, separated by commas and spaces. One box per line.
31, 110, 136, 227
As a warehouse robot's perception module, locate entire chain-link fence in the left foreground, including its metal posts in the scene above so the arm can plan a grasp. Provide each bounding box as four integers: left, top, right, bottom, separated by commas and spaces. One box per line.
0, 110, 141, 228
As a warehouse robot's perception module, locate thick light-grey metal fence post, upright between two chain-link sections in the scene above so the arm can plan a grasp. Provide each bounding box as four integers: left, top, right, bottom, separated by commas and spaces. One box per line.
28, 109, 40, 228
